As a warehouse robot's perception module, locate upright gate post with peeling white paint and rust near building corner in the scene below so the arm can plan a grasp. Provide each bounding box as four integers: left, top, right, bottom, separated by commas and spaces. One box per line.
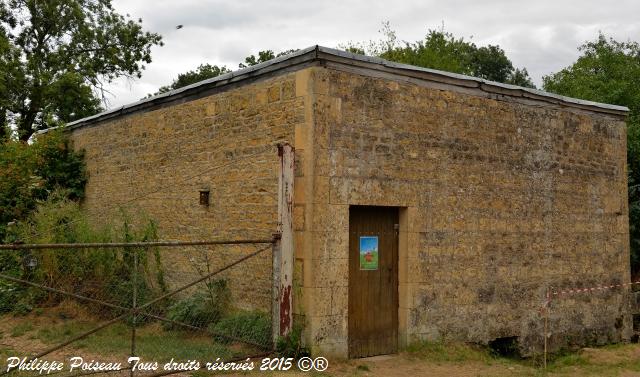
274, 143, 295, 336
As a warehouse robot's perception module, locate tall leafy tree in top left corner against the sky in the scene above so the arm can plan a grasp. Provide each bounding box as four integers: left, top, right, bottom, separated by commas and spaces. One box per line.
0, 0, 162, 140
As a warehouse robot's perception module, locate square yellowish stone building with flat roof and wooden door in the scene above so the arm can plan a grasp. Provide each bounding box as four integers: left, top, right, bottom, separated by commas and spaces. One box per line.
58, 46, 631, 357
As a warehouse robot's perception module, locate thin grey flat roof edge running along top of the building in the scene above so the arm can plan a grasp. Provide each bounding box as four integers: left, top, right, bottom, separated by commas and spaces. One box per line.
39, 45, 629, 133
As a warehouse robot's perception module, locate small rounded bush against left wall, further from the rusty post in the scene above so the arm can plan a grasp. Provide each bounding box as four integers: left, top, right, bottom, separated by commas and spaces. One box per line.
163, 279, 231, 329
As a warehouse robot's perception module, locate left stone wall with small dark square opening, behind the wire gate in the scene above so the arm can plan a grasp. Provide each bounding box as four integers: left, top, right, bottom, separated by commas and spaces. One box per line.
72, 75, 304, 310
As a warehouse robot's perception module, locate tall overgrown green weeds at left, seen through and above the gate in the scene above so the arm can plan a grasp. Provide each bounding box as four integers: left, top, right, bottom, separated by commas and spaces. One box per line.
0, 192, 164, 314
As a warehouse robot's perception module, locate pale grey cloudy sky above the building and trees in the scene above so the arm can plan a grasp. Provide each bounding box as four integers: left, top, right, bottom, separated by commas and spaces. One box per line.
110, 0, 640, 107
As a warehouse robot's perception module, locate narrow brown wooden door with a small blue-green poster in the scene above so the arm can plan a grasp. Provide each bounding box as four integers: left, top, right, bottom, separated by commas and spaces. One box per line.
349, 206, 398, 358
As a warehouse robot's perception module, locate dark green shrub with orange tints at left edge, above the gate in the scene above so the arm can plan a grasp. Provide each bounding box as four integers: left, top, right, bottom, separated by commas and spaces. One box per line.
0, 131, 87, 242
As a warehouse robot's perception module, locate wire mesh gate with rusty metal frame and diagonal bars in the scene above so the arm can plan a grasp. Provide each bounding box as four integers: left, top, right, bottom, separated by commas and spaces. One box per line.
0, 238, 277, 376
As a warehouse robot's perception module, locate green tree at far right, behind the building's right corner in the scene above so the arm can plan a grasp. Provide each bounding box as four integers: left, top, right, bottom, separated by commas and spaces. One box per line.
543, 34, 640, 276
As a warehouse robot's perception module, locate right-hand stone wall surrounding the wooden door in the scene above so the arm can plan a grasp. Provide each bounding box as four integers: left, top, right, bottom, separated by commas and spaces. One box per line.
296, 68, 631, 356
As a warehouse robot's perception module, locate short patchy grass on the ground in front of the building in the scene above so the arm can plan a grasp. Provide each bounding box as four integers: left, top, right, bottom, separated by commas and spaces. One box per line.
11, 308, 640, 377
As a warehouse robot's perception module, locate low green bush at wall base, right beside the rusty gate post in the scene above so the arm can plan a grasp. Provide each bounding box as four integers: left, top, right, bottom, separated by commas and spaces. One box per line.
209, 311, 271, 347
